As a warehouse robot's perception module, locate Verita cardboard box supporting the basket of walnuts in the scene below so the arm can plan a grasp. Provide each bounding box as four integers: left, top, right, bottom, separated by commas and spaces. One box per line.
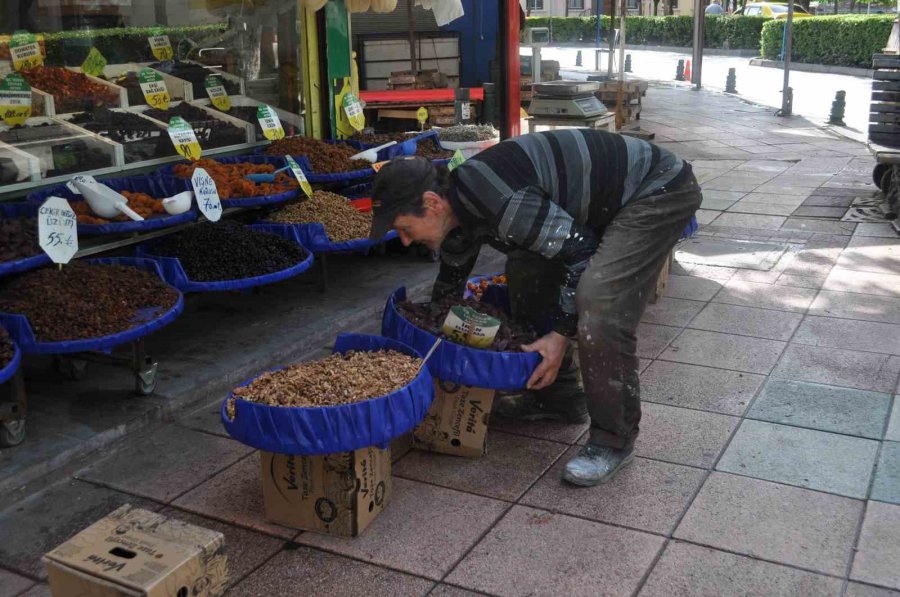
260, 447, 391, 537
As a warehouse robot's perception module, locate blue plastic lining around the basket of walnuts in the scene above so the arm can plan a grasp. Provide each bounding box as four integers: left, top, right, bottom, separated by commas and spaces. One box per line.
221, 334, 434, 456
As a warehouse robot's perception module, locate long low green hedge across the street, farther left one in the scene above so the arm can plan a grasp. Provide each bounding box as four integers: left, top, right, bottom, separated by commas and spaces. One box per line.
526, 16, 768, 50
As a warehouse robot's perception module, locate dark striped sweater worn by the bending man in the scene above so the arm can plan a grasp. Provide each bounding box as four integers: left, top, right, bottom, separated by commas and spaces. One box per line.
434, 129, 690, 336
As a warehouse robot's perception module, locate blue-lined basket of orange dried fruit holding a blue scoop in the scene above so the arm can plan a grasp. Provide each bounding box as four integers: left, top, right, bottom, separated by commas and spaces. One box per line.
157, 155, 300, 207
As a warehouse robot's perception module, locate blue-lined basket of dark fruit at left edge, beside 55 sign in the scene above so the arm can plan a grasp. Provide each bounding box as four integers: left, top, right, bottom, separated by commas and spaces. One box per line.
0, 203, 50, 276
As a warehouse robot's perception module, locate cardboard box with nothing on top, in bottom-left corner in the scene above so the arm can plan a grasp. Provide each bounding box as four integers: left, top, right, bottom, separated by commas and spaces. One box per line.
44, 504, 228, 597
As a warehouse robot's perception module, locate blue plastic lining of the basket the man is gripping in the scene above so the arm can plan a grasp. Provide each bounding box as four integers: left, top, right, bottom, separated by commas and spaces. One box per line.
381, 287, 541, 391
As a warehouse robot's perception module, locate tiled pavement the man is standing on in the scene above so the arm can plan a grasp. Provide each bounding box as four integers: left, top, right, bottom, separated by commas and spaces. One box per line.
0, 88, 900, 597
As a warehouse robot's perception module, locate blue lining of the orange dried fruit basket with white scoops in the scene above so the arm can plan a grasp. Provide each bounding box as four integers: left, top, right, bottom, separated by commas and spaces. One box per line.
28, 176, 197, 236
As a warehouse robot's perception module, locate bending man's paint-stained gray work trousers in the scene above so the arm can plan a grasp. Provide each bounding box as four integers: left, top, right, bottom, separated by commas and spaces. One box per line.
506, 177, 702, 448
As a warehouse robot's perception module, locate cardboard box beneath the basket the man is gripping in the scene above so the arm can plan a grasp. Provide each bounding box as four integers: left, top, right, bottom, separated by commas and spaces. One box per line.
413, 379, 496, 458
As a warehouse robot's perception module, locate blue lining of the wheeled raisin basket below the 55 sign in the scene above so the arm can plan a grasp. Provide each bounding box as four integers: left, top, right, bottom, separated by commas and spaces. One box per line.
0, 257, 184, 354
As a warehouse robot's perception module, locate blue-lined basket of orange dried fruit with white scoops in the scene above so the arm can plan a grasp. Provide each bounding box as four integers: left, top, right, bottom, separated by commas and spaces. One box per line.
28, 176, 197, 235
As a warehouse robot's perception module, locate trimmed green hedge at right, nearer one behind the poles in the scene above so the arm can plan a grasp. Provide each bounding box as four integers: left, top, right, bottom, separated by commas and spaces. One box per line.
760, 15, 895, 68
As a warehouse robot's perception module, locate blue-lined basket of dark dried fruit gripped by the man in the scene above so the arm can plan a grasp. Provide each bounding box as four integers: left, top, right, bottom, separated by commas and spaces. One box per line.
381, 287, 541, 391
